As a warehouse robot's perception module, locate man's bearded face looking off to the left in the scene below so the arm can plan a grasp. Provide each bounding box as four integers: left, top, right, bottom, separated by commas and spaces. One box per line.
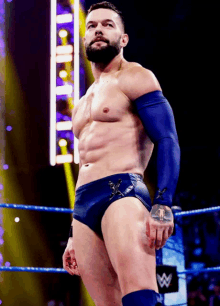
84, 9, 123, 64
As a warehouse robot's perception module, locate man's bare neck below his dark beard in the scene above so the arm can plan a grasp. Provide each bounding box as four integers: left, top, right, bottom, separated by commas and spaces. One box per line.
91, 54, 124, 82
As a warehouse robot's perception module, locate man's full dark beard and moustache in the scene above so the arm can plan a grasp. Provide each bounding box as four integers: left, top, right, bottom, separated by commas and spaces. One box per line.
85, 38, 121, 64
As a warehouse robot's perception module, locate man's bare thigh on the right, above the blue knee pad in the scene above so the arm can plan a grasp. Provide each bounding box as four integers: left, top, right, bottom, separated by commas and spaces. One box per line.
101, 197, 158, 296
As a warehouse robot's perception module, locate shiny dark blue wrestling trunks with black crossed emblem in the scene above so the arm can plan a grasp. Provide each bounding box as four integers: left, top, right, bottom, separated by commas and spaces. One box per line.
73, 173, 151, 240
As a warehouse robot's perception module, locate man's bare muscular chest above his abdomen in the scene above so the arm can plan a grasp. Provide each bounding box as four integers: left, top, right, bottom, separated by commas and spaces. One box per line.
73, 80, 131, 138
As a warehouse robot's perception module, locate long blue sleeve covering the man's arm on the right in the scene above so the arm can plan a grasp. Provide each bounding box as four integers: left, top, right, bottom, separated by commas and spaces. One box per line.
133, 90, 180, 207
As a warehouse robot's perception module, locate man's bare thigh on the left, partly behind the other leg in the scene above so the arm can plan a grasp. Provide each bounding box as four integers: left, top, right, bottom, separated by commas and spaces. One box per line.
72, 219, 122, 306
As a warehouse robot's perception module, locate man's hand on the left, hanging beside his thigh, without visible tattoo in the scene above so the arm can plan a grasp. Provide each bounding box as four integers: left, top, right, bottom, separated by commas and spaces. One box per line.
63, 237, 80, 276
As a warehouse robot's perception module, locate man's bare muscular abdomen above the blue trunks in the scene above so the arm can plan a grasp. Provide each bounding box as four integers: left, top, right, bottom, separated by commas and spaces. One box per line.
76, 116, 153, 189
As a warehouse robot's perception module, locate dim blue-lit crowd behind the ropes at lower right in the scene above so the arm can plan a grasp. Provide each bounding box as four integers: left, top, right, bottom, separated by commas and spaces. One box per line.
175, 183, 220, 306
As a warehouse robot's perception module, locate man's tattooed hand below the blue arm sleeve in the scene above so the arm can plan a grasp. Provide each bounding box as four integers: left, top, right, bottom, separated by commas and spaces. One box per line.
146, 204, 174, 250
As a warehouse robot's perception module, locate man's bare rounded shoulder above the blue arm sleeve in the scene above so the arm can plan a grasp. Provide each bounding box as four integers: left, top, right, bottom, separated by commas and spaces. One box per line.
119, 62, 161, 100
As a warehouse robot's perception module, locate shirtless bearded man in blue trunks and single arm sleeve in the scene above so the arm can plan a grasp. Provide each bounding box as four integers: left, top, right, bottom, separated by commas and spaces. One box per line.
63, 2, 180, 306
